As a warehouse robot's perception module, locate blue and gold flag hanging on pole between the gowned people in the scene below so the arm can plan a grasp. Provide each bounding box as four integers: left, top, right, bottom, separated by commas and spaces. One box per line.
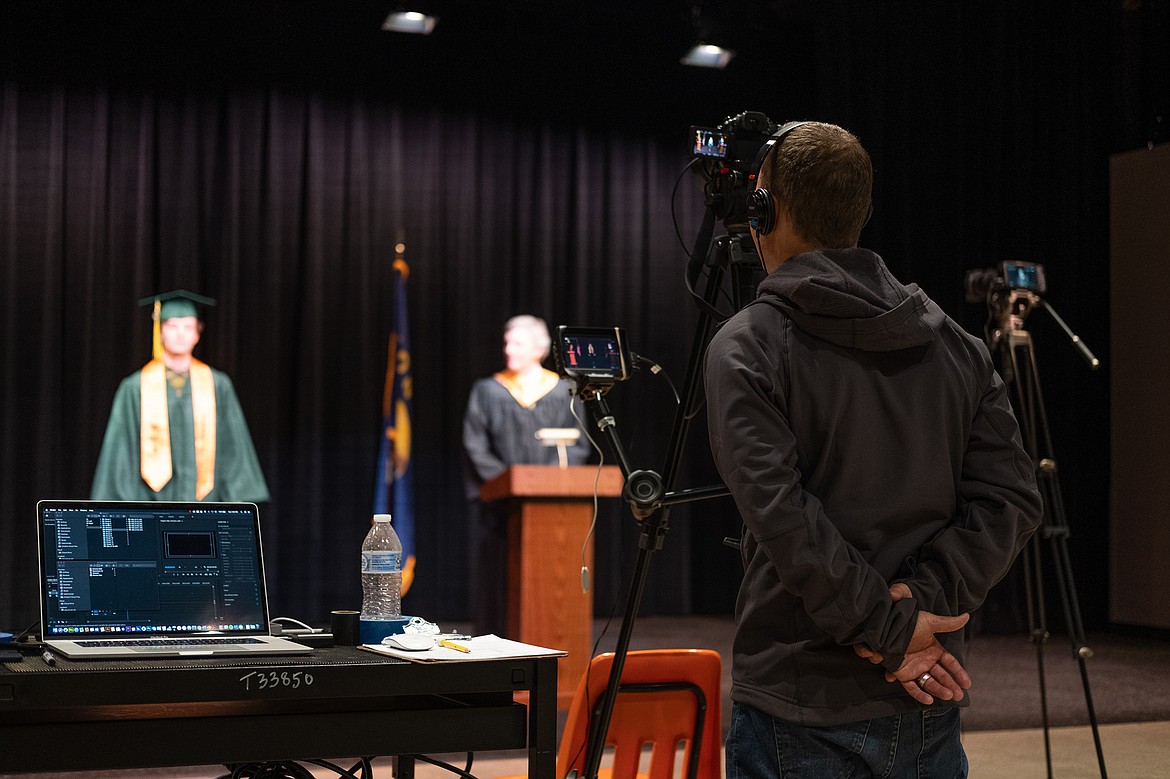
373, 256, 414, 595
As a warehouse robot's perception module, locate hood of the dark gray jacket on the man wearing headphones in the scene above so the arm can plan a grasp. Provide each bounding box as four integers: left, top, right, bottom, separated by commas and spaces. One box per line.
753, 248, 947, 352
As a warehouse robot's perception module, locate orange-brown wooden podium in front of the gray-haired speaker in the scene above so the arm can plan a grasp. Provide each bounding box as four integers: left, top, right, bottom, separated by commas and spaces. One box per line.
480, 466, 624, 709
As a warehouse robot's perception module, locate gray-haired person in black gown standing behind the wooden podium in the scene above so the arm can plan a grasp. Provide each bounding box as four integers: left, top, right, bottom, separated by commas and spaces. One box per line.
463, 315, 590, 635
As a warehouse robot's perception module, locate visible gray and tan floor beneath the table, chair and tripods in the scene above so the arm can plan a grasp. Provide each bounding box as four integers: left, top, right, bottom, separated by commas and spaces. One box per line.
0, 616, 1170, 779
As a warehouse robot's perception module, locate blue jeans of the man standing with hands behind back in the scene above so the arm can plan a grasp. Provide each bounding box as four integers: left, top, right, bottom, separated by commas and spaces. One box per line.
727, 703, 966, 779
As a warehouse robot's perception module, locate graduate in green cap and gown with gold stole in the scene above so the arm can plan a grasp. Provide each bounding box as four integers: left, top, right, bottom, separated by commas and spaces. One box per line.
90, 290, 269, 503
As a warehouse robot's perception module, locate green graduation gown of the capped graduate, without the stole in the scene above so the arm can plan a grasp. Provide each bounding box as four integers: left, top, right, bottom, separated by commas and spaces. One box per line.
90, 368, 269, 503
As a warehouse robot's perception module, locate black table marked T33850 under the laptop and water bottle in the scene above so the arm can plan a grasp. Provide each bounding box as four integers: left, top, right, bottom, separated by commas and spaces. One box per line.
0, 647, 557, 779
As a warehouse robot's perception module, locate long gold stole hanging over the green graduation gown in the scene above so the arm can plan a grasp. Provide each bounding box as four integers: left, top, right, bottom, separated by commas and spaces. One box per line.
139, 358, 215, 501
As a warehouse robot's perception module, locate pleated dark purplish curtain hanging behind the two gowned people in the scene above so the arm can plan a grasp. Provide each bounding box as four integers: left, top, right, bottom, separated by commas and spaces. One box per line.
0, 76, 727, 621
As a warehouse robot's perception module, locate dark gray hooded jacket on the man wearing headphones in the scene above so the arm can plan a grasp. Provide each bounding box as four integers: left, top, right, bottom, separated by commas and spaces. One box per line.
706, 249, 1041, 725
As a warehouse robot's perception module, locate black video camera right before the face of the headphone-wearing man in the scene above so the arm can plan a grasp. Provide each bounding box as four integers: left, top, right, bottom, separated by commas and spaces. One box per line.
690, 111, 778, 227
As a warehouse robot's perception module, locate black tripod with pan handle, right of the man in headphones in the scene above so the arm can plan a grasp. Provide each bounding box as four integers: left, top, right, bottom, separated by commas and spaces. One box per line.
993, 289, 1107, 779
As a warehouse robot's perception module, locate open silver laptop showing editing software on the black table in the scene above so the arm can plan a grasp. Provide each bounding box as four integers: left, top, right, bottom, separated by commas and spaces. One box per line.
36, 501, 312, 660
